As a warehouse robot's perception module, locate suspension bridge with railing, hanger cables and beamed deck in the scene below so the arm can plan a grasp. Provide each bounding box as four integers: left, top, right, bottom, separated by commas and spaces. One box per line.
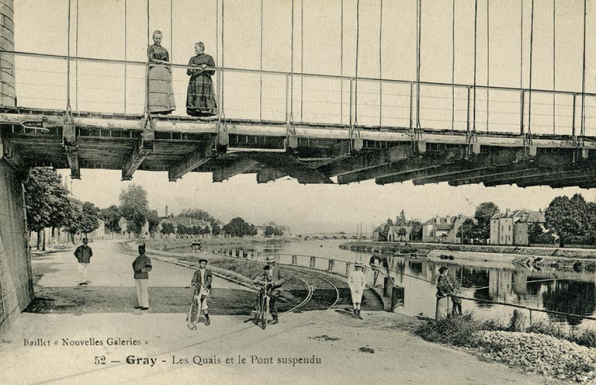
0, 0, 596, 188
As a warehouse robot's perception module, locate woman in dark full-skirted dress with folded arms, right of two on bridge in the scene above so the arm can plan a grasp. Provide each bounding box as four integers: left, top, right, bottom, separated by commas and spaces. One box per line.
186, 43, 217, 116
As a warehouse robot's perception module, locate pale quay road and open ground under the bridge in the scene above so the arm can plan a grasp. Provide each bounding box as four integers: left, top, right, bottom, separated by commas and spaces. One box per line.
0, 241, 557, 385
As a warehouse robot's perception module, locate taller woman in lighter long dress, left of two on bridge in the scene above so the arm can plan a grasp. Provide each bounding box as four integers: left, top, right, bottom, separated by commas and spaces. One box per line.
147, 31, 176, 115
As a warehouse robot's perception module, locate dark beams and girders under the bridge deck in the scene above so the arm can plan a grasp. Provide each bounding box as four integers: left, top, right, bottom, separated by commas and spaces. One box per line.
0, 109, 596, 188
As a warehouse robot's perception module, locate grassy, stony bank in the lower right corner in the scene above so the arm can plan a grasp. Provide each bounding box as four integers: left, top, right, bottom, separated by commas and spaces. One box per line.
415, 311, 596, 383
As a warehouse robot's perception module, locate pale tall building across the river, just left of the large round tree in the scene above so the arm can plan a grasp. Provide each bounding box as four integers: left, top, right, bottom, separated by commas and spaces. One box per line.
490, 209, 545, 246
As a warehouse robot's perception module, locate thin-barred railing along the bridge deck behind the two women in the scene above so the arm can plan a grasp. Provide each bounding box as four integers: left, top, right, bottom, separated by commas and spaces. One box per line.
0, 51, 596, 136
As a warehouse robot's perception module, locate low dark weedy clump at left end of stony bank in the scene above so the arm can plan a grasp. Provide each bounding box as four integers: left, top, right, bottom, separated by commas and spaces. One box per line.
414, 312, 481, 347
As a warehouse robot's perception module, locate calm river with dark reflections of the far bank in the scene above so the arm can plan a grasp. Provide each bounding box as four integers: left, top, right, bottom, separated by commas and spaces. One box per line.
201, 240, 596, 327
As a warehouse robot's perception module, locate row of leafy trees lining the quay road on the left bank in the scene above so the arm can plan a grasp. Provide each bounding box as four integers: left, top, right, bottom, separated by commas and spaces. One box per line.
25, 167, 284, 250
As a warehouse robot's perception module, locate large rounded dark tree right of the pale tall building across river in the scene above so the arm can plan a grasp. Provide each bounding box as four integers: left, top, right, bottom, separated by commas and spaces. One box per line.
544, 194, 588, 247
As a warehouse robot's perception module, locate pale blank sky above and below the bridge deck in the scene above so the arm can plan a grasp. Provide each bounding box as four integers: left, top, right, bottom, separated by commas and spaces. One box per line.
15, 0, 596, 233
